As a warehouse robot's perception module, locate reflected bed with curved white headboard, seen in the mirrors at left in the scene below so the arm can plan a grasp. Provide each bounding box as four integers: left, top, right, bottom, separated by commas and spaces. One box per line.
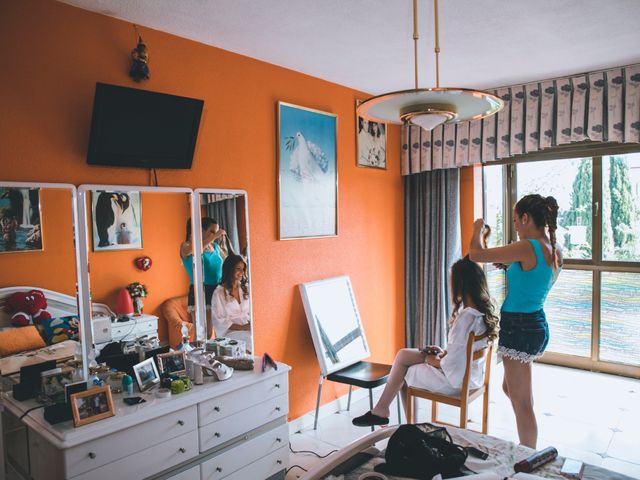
0, 286, 115, 376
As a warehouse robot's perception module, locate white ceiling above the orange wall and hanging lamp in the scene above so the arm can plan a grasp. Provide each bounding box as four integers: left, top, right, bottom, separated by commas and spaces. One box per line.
61, 0, 640, 94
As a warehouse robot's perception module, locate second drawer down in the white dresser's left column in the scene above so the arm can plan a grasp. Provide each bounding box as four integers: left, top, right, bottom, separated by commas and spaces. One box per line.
73, 430, 196, 480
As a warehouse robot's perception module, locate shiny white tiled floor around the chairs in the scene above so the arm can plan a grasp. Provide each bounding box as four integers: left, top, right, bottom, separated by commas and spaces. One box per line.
286, 364, 640, 480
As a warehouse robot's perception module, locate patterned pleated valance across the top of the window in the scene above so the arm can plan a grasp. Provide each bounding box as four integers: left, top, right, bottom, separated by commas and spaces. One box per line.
401, 64, 640, 175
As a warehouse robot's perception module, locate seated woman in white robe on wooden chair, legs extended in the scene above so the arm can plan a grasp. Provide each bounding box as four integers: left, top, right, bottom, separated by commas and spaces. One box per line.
352, 256, 499, 427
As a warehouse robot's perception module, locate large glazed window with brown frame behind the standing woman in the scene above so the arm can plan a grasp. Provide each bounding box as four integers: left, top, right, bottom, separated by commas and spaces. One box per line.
483, 153, 640, 376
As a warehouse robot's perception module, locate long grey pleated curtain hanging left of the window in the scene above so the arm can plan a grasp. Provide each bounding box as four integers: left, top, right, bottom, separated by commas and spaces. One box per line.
404, 168, 461, 348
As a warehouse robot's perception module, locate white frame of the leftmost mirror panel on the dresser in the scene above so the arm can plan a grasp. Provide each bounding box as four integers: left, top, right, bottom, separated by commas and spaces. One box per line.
0, 181, 87, 381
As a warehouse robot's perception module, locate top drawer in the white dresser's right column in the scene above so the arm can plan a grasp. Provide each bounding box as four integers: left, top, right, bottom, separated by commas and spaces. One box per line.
198, 372, 288, 426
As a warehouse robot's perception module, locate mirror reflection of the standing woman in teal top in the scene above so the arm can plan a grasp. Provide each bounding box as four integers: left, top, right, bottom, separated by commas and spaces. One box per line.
180, 217, 225, 338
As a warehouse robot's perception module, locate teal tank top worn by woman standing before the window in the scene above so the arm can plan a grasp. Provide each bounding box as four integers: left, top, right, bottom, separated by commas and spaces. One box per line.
502, 240, 556, 313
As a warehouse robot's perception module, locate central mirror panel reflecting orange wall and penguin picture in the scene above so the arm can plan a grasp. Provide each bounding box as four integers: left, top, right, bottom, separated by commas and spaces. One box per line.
78, 185, 197, 354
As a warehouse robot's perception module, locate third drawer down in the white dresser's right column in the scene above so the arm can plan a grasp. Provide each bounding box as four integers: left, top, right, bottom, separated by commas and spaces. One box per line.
201, 424, 289, 480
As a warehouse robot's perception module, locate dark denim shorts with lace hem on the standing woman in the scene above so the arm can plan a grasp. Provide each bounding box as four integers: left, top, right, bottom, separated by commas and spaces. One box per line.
498, 309, 549, 363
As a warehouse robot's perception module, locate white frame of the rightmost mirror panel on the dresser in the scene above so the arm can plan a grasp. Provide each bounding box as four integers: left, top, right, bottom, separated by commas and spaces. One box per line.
191, 188, 255, 355
